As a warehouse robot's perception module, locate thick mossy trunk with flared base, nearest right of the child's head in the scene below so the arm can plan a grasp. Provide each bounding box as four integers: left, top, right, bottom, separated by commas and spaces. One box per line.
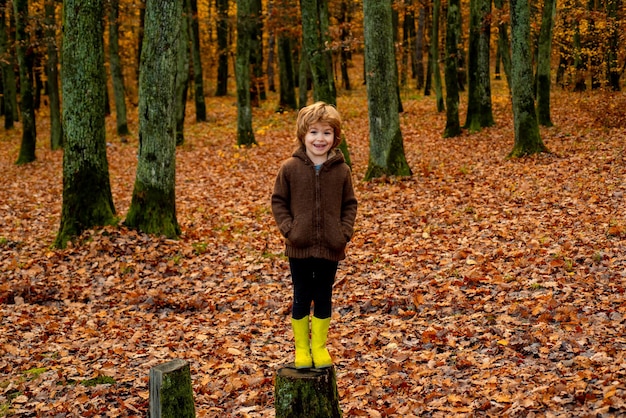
363, 0, 411, 180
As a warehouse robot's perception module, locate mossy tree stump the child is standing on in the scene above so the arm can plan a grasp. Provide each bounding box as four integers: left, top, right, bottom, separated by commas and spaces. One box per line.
274, 365, 341, 418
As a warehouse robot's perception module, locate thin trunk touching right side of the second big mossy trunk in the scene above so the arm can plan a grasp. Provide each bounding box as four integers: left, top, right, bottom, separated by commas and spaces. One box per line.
175, 2, 191, 146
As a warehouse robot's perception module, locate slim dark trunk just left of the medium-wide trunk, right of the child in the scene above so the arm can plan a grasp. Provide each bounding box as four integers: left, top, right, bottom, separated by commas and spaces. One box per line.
443, 0, 461, 138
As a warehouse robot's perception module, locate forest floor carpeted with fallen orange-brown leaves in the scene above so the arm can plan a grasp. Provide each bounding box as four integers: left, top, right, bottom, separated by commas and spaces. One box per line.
0, 86, 626, 417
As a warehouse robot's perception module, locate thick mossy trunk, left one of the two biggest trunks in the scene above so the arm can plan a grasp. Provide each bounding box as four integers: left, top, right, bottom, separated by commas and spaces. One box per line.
54, 0, 116, 248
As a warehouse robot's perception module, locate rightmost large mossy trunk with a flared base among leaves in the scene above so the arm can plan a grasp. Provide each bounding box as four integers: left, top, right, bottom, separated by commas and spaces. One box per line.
509, 0, 547, 158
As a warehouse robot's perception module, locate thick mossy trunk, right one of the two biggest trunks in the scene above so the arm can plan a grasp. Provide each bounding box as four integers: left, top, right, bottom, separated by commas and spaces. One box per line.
125, 0, 183, 238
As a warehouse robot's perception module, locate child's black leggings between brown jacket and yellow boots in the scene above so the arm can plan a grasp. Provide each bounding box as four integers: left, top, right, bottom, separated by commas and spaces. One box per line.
289, 258, 339, 319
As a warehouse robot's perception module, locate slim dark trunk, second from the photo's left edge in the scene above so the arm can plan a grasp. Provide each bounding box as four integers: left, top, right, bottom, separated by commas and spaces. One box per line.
13, 0, 37, 165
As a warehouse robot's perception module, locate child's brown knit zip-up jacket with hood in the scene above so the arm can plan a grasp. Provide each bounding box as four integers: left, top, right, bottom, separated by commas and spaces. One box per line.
272, 147, 357, 261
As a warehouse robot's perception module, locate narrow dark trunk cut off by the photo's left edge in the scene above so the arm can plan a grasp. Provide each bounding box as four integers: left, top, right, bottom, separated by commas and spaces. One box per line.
0, 0, 18, 129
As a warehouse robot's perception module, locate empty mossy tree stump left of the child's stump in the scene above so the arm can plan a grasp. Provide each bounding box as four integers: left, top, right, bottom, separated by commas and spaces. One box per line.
150, 359, 196, 418
